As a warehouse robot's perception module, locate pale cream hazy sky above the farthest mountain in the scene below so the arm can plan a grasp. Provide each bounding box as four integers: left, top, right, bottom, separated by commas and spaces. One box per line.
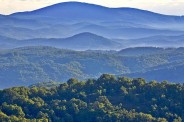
0, 0, 184, 15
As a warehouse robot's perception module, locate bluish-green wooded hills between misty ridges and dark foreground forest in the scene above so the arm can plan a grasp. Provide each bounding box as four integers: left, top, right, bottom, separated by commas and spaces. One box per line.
0, 46, 184, 89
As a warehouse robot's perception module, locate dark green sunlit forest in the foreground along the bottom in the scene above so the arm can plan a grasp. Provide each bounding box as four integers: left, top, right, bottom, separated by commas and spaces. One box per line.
0, 74, 184, 122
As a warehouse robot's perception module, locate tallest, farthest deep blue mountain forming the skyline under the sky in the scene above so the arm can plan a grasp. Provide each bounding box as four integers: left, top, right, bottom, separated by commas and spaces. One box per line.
11, 2, 184, 23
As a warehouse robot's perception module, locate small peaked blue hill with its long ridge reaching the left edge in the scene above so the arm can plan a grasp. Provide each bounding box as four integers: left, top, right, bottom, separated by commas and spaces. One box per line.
0, 32, 122, 50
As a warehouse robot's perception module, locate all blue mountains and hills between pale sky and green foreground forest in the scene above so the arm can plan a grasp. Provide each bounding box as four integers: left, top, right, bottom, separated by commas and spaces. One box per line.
0, 2, 184, 88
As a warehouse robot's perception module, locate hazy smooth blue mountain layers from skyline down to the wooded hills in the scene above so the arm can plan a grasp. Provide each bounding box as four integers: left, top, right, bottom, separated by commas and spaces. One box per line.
0, 2, 184, 50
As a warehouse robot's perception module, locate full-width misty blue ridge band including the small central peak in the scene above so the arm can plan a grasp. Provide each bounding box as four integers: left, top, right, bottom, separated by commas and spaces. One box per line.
0, 32, 184, 51
